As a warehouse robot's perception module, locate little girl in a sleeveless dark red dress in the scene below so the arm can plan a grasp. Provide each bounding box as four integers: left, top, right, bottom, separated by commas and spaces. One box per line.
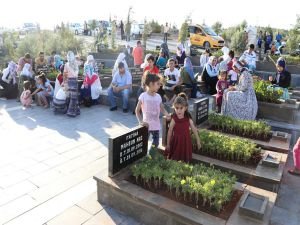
166, 93, 201, 163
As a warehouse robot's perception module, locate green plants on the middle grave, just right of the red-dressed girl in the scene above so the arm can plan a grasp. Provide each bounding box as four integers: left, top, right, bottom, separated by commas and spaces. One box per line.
192, 130, 261, 163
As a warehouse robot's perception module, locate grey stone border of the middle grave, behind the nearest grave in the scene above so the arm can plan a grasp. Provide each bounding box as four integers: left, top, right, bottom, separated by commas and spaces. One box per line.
193, 151, 288, 192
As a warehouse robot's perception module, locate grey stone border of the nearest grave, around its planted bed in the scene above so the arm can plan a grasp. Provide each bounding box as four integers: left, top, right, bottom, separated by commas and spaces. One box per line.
94, 170, 277, 225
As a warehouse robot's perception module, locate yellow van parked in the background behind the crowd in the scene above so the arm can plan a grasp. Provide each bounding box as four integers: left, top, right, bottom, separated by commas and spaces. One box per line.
189, 24, 224, 53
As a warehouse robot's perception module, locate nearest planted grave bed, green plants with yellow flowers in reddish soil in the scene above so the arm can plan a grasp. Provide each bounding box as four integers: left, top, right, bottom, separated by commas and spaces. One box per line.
128, 155, 243, 220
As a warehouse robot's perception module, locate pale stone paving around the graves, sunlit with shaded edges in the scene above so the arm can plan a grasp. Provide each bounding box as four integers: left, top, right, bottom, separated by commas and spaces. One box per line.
0, 99, 300, 225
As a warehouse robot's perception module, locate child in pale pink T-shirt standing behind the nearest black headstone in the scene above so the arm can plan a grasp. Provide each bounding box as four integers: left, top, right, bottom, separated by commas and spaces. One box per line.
135, 73, 169, 147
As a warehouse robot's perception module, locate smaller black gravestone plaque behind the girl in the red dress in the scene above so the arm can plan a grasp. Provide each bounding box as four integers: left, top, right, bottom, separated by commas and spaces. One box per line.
193, 98, 209, 126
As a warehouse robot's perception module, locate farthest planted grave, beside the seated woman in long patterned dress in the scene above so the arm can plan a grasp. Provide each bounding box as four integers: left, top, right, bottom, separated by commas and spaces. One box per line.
203, 113, 291, 153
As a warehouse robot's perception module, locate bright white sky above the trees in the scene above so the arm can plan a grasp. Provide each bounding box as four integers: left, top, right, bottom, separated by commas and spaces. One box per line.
0, 0, 300, 29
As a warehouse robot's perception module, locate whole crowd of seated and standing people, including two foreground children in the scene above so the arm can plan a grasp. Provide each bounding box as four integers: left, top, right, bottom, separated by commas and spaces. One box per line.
0, 38, 291, 162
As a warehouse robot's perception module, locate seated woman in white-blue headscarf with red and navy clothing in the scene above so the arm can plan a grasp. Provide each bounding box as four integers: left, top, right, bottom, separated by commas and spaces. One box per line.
80, 64, 102, 107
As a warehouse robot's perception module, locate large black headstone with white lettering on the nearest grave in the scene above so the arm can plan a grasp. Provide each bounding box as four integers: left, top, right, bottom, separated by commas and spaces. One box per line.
108, 126, 148, 177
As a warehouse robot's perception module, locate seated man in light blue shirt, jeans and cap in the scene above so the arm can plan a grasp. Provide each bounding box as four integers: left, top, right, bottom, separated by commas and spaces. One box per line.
108, 62, 132, 113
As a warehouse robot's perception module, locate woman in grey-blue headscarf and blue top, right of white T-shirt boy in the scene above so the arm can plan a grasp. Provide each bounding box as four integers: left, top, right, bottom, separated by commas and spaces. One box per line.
180, 57, 197, 98
